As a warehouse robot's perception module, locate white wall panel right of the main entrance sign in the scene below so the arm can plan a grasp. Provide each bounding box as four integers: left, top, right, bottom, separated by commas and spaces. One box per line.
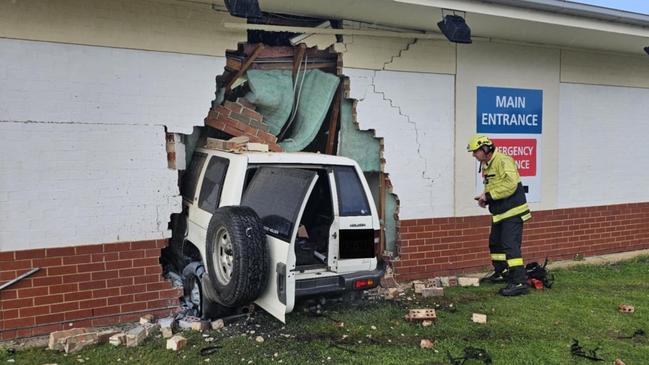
557, 83, 649, 208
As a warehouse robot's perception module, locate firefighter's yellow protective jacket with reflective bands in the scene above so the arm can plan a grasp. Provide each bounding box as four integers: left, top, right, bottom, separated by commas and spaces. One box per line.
481, 151, 532, 223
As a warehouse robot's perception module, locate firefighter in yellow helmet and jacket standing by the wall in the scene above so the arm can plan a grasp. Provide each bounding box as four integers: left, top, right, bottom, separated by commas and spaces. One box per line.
467, 134, 532, 296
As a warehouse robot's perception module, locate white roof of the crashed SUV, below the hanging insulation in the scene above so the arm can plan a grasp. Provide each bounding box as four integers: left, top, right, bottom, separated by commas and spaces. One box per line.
196, 147, 356, 166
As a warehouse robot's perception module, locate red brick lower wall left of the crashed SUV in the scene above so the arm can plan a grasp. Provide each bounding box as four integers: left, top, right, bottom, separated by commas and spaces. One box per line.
0, 240, 182, 340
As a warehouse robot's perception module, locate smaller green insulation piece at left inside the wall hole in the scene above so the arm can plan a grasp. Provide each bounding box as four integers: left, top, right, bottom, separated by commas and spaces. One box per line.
245, 70, 293, 136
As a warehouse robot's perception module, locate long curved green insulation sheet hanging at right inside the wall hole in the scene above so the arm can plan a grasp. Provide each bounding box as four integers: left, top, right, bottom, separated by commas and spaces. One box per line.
279, 70, 340, 152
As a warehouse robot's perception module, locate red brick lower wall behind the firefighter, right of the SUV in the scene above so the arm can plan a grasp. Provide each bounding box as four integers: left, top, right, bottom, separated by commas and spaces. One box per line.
394, 203, 649, 280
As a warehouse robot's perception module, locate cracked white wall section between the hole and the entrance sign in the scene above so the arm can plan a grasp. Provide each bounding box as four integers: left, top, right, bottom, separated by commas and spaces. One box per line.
343, 68, 454, 219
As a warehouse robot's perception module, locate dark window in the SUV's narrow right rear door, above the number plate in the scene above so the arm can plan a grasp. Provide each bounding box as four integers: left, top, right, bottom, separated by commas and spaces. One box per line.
334, 166, 371, 216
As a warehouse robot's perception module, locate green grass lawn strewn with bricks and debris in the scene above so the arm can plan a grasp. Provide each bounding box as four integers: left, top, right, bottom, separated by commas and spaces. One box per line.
0, 257, 649, 365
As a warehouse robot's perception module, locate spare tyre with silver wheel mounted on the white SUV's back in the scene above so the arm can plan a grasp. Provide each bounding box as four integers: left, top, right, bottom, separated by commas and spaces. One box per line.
205, 206, 269, 307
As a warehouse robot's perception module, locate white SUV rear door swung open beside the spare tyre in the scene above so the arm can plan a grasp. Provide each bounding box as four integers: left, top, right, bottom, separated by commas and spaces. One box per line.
241, 167, 318, 322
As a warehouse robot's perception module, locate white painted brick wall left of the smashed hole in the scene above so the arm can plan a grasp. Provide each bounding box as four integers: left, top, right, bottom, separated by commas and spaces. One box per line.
0, 39, 224, 251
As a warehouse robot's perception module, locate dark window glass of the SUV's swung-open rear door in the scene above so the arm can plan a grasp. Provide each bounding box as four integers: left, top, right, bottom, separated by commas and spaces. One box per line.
241, 167, 317, 241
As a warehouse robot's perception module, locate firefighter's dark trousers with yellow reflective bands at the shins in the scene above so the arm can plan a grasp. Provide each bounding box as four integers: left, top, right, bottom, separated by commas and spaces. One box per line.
489, 217, 527, 284
